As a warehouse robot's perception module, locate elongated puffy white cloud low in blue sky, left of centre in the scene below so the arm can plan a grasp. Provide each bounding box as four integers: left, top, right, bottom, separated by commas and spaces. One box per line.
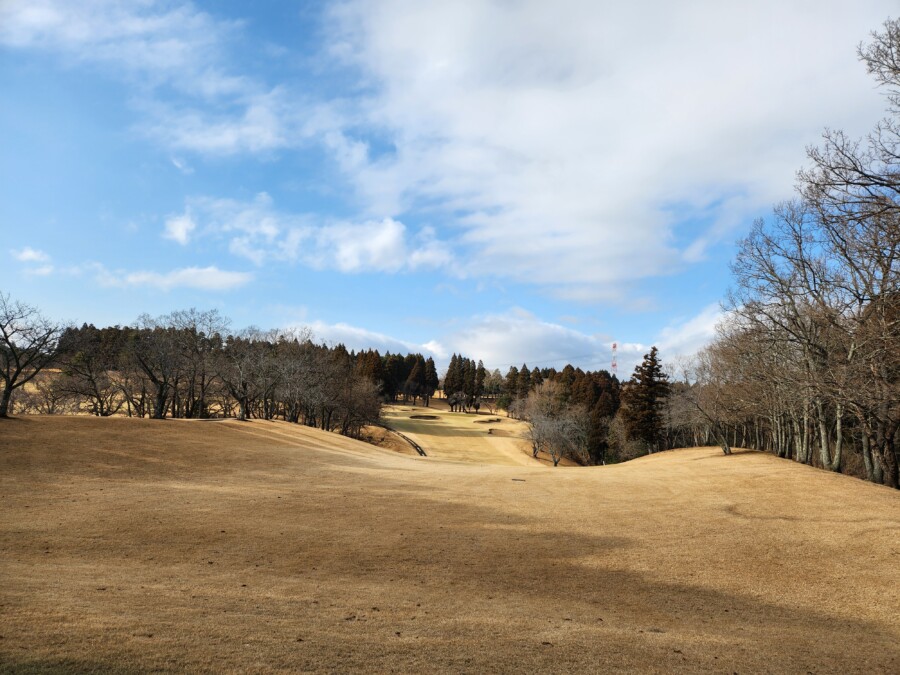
165, 192, 453, 273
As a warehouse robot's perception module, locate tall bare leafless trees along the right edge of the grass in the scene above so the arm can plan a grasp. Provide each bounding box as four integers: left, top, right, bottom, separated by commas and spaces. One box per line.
673, 20, 900, 488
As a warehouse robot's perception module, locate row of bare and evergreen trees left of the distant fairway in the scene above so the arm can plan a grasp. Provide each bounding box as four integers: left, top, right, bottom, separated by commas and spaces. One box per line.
0, 302, 450, 438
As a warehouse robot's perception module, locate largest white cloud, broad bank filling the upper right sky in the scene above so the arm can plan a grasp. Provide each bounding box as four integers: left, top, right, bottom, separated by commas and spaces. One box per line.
326, 0, 895, 300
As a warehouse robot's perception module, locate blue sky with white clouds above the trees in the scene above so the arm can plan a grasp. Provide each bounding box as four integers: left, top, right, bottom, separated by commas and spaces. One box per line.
0, 0, 897, 378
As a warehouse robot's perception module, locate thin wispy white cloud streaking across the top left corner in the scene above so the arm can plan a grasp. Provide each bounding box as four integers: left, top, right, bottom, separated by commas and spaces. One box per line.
0, 0, 304, 159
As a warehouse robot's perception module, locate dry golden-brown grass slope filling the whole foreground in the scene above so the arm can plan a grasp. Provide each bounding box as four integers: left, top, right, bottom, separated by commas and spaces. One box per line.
0, 417, 900, 673
